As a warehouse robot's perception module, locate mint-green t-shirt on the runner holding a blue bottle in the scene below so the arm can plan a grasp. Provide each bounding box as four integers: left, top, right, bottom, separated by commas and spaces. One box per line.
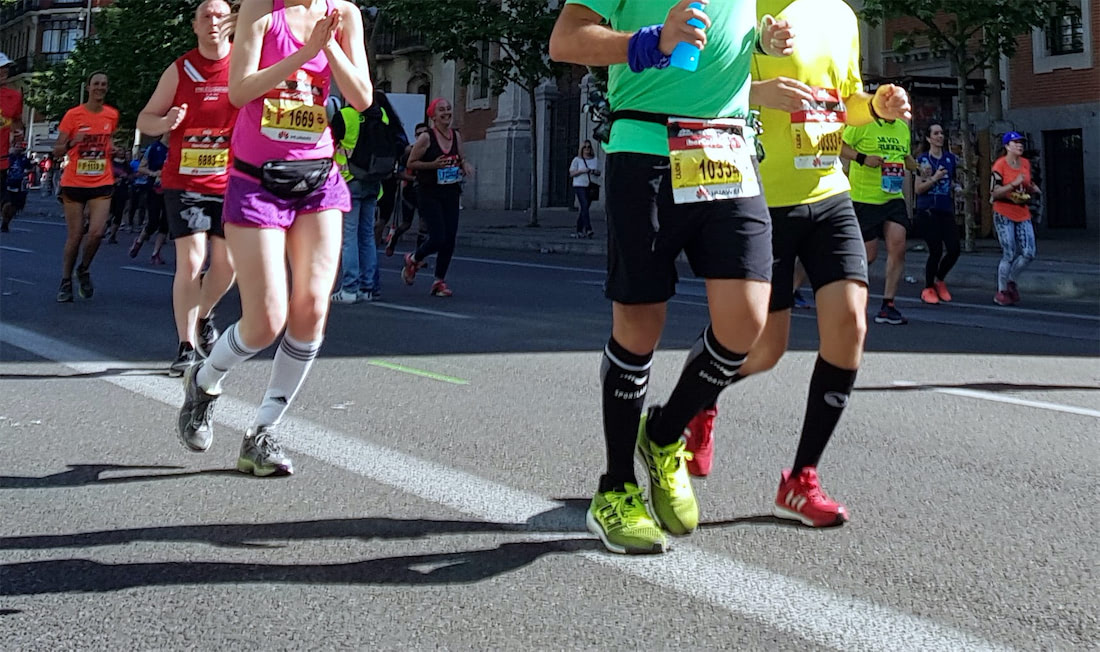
568, 0, 757, 156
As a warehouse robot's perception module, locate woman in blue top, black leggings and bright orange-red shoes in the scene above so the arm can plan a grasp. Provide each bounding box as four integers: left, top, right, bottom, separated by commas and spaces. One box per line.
914, 123, 959, 303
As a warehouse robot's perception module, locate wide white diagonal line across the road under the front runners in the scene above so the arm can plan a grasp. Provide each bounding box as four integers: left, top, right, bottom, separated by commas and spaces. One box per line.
0, 324, 1003, 651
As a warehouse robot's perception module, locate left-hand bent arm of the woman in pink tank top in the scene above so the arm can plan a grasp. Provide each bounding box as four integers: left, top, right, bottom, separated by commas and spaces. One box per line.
229, 0, 314, 108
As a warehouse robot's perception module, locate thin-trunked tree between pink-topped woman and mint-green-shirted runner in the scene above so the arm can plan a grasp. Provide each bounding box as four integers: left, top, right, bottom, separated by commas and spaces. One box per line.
378, 0, 564, 226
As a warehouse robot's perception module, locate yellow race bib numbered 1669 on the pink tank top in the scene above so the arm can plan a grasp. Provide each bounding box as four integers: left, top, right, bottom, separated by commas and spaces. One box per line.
260, 70, 329, 145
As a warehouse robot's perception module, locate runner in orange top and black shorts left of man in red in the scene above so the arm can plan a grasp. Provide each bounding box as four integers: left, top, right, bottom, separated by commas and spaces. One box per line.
54, 73, 119, 303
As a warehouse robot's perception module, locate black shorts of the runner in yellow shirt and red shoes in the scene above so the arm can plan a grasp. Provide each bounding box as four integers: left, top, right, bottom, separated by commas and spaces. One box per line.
769, 192, 867, 312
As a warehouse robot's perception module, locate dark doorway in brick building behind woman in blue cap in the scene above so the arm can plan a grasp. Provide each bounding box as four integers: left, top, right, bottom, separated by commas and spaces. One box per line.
1043, 129, 1085, 229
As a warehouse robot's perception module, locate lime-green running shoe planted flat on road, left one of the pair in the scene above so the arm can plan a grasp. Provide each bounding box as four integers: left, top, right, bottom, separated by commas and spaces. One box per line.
584, 483, 668, 554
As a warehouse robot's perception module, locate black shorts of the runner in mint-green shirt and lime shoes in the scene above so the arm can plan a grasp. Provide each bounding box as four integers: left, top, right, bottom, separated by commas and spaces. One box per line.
604, 152, 771, 303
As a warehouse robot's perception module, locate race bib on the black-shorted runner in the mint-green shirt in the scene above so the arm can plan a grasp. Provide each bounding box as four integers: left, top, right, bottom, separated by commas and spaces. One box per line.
669, 118, 760, 203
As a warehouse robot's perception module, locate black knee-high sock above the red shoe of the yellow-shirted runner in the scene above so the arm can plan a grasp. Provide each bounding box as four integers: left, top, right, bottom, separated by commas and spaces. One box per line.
791, 355, 858, 476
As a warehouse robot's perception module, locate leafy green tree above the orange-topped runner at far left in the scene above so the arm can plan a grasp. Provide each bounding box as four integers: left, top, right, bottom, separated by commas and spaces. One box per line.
26, 0, 199, 145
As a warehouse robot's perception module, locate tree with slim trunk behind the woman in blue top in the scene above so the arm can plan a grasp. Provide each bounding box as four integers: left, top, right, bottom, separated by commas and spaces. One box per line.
861, 0, 1076, 252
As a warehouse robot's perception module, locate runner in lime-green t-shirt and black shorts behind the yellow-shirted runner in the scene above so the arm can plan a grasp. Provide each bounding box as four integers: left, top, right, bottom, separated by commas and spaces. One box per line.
840, 115, 916, 325
